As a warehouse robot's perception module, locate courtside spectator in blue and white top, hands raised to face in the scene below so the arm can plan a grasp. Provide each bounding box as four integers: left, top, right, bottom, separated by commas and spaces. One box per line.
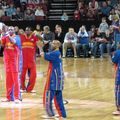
76, 26, 89, 58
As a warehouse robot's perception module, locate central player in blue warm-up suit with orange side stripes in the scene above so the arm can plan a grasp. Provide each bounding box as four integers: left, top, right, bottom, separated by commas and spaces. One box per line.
41, 40, 66, 119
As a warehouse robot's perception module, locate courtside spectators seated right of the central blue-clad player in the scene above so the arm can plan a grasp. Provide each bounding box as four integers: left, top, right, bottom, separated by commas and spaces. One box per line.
63, 16, 120, 58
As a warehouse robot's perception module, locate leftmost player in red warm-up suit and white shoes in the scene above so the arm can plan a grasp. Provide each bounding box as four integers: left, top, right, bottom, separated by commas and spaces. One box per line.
1, 26, 21, 103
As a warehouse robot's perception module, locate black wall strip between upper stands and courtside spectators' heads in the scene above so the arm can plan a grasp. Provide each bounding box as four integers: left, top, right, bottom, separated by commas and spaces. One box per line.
4, 20, 110, 33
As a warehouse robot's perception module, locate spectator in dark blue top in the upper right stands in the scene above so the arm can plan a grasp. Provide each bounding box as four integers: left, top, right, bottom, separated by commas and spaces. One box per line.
101, 2, 111, 16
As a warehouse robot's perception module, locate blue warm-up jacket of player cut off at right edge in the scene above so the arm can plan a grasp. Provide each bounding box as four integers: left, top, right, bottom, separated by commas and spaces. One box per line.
112, 50, 120, 85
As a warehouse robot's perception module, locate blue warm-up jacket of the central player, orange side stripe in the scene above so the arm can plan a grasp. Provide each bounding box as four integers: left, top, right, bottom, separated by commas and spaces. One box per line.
44, 50, 64, 90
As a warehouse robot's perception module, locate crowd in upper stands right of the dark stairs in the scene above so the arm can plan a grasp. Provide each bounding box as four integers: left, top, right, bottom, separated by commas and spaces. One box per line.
74, 0, 120, 20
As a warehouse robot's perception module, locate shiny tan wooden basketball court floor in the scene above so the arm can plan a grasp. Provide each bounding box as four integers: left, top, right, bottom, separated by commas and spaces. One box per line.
0, 57, 120, 120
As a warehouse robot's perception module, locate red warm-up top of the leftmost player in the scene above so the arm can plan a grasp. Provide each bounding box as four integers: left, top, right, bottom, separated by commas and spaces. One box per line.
1, 36, 19, 72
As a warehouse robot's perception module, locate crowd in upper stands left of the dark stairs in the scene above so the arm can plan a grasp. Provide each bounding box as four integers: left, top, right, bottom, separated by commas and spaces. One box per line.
0, 0, 47, 21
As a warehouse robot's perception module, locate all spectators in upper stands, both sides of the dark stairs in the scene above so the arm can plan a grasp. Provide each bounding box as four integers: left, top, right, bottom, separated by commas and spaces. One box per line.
0, 0, 120, 21
